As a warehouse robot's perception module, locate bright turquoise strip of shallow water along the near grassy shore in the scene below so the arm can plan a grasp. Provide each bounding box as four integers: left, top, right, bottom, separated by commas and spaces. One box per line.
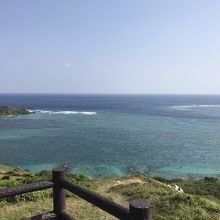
9, 164, 220, 180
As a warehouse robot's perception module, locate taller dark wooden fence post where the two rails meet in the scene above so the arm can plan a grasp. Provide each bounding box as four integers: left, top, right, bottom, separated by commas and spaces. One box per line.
52, 167, 66, 219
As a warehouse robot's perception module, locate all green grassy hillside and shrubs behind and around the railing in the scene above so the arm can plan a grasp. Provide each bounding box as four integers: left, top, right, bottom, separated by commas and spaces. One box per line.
0, 166, 220, 220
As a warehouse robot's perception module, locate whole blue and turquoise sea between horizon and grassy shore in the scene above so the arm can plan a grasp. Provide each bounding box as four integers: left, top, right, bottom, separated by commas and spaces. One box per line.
0, 95, 220, 178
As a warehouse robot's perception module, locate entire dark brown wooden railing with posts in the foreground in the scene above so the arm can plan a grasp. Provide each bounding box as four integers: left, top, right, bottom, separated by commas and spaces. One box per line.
0, 167, 151, 220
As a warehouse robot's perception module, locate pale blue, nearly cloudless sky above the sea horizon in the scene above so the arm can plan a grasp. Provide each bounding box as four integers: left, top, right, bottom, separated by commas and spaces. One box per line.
0, 0, 220, 94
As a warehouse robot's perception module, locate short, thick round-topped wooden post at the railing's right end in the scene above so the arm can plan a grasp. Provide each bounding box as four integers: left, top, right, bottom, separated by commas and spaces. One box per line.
129, 199, 152, 220
